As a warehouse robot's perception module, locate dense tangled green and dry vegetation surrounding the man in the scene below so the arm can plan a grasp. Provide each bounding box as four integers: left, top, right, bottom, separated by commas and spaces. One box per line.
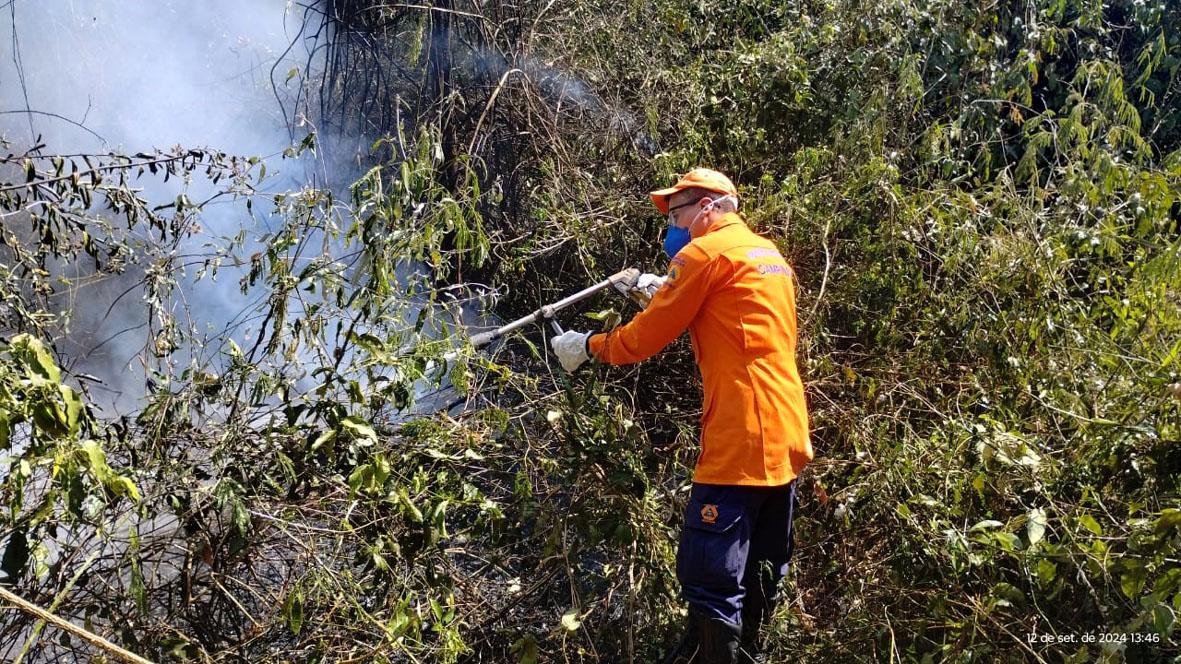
0, 0, 1181, 663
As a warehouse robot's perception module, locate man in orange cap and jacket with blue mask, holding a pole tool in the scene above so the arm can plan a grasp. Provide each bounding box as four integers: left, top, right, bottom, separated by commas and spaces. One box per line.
550, 168, 813, 664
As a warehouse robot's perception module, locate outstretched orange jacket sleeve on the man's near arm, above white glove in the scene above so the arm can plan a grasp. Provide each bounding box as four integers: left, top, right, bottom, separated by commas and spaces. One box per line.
589, 245, 725, 364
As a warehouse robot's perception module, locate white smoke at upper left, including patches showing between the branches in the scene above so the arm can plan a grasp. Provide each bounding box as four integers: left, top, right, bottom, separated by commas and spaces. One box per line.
0, 0, 307, 412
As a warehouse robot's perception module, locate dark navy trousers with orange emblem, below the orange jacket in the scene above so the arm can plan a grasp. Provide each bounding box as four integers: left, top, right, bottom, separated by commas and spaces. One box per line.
677, 481, 796, 626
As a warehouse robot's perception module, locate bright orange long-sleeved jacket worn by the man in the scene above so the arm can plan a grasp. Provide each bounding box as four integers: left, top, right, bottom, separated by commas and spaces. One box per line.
589, 214, 813, 486
